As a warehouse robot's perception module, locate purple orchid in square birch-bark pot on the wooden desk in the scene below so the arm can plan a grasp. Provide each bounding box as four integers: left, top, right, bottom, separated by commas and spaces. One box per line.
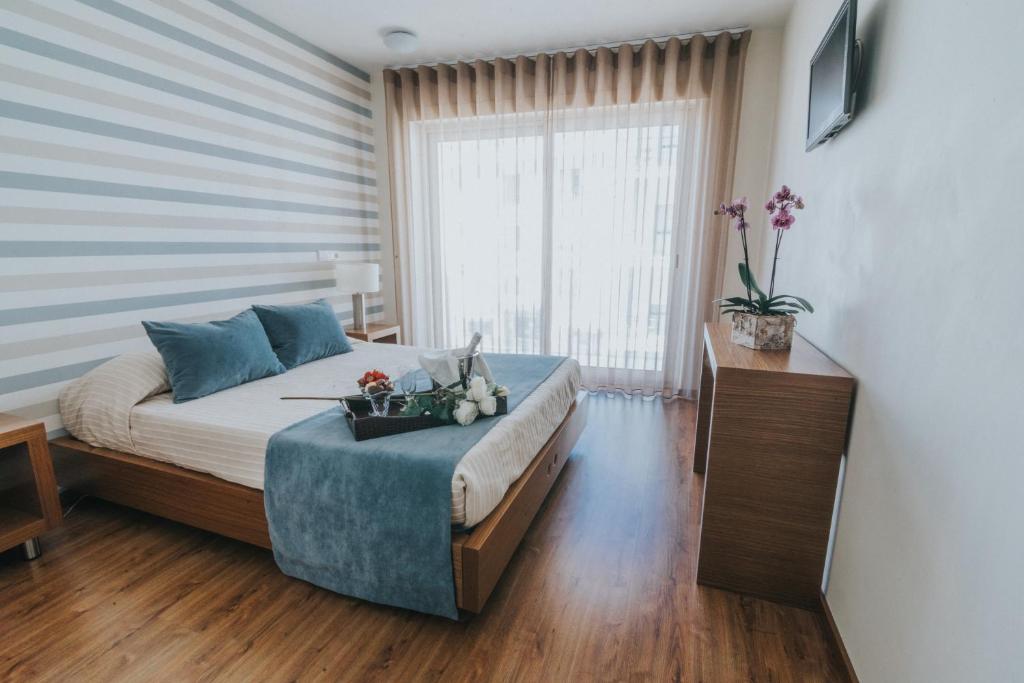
715, 185, 814, 350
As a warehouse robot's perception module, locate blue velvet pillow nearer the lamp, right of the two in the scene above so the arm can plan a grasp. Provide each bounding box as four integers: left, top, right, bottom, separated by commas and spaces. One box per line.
253, 299, 352, 370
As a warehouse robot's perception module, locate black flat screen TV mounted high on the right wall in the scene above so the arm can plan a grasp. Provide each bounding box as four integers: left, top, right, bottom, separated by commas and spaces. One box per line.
807, 0, 859, 152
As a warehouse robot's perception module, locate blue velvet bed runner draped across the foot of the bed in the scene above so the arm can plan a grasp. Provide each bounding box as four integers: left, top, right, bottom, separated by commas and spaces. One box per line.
264, 353, 565, 618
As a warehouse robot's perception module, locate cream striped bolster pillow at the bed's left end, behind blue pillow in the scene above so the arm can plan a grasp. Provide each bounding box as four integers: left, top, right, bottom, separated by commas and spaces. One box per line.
59, 351, 171, 453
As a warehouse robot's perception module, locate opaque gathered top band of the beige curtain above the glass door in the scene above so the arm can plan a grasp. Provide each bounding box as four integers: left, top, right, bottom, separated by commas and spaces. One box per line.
384, 32, 750, 115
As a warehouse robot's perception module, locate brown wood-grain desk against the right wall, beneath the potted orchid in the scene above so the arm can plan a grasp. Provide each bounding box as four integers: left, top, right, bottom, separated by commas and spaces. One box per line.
693, 323, 854, 609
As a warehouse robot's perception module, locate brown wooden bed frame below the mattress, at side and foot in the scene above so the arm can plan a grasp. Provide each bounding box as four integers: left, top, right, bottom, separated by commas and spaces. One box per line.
50, 391, 587, 612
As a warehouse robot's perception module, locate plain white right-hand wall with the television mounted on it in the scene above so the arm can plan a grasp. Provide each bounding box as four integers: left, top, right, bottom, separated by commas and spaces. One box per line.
761, 0, 1024, 683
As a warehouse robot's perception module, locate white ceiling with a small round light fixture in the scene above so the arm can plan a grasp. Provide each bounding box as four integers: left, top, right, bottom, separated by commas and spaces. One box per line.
239, 0, 793, 67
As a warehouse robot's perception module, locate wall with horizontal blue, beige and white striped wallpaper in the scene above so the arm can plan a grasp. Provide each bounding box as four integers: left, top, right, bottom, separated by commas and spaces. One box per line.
0, 0, 381, 436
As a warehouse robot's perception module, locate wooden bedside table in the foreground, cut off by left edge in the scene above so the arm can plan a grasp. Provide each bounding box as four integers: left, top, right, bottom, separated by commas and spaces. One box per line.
0, 413, 61, 560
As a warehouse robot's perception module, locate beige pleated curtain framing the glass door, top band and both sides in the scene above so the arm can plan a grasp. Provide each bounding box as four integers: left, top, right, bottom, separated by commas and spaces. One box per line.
384, 32, 750, 393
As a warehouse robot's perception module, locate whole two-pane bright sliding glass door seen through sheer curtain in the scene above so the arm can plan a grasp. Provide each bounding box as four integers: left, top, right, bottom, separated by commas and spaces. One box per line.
414, 101, 699, 391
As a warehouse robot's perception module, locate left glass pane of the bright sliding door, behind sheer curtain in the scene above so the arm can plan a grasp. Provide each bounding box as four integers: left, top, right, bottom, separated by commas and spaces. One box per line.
431, 122, 548, 353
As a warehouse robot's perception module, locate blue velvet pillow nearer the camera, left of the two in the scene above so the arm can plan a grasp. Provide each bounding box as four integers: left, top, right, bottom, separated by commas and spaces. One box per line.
142, 310, 285, 403
